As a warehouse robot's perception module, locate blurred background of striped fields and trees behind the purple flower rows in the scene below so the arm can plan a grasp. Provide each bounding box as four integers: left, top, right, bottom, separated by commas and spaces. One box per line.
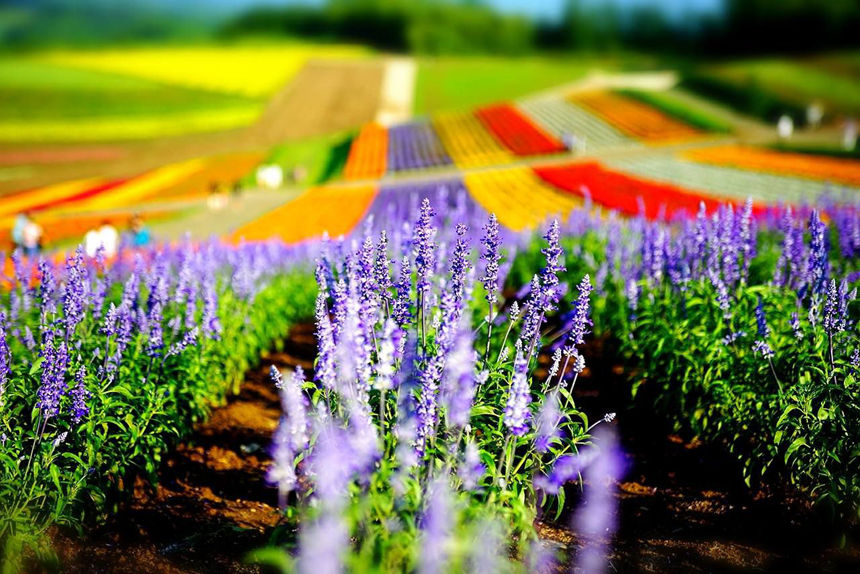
0, 0, 860, 252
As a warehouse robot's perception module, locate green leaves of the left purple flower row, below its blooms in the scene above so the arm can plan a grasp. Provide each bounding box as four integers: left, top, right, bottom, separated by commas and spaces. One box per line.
0, 273, 313, 563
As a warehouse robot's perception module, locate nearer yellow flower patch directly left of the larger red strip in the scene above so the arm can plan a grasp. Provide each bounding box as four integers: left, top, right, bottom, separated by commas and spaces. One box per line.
463, 167, 582, 231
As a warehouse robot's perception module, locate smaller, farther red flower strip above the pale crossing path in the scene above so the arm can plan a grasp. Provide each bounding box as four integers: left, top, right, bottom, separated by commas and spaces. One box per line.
475, 104, 565, 155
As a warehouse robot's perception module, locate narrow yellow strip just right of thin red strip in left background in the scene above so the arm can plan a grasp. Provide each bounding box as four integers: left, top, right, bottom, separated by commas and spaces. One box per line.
64, 159, 206, 211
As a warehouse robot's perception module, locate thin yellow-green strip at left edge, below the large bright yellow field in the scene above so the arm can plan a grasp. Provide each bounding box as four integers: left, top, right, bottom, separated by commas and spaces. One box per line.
0, 108, 261, 142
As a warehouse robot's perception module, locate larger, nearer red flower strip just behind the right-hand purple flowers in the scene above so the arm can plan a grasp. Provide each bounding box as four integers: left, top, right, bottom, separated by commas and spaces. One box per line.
534, 162, 762, 219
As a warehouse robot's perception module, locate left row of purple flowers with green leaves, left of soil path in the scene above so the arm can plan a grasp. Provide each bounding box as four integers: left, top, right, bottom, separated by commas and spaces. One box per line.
0, 242, 313, 563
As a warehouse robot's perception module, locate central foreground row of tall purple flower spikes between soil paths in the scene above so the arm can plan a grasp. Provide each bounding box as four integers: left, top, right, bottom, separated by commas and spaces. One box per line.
262, 201, 623, 573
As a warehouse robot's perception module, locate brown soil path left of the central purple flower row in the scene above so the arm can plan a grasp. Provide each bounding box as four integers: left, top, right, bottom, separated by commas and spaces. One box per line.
47, 325, 315, 574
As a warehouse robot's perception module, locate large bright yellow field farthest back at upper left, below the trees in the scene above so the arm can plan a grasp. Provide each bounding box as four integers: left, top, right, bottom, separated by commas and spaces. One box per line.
42, 44, 367, 97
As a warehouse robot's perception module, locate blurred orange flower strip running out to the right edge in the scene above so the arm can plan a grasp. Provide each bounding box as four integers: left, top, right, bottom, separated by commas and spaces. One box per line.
684, 145, 860, 187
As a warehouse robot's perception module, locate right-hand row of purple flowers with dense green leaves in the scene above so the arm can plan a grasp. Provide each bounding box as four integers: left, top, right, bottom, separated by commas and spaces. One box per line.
514, 199, 860, 521
